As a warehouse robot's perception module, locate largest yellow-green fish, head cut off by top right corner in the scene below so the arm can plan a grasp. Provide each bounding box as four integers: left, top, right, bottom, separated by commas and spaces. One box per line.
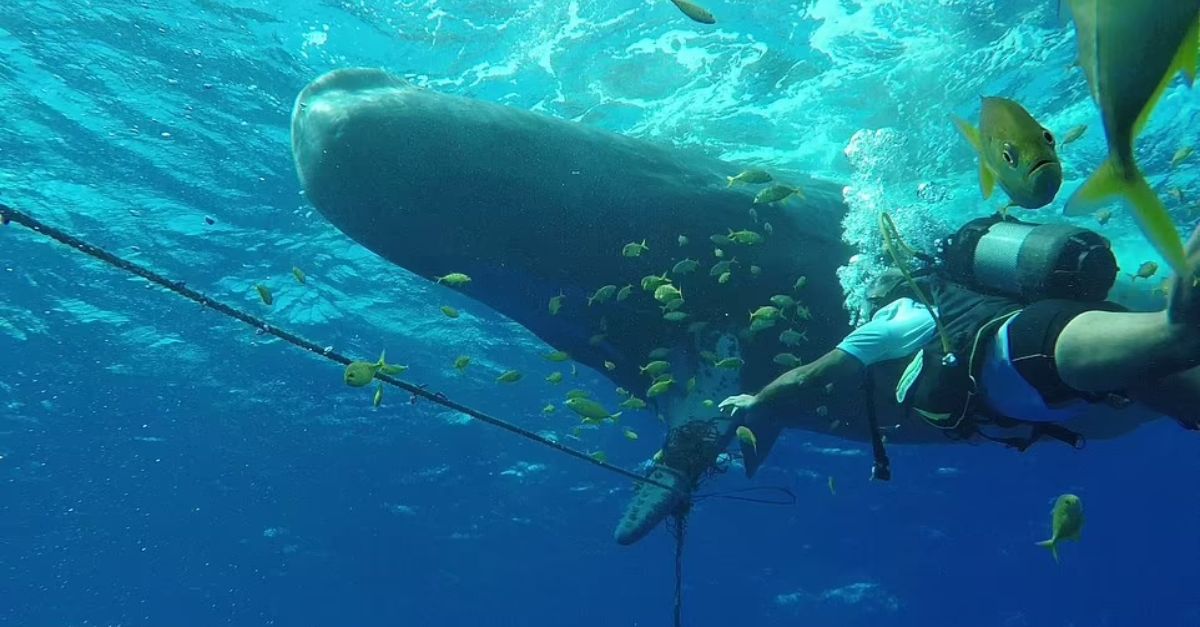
1060, 0, 1200, 276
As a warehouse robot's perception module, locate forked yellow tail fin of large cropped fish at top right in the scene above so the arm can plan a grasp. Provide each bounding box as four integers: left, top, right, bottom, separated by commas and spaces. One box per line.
1064, 156, 1192, 276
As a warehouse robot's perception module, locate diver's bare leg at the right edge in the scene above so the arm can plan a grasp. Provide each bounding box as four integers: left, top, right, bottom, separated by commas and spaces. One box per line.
1055, 228, 1200, 392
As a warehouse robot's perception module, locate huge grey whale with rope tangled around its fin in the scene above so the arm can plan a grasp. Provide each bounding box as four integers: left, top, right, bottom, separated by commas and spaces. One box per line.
285, 68, 1156, 544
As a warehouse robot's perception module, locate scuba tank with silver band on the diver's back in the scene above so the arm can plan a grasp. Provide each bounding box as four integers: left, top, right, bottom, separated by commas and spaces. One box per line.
935, 216, 1117, 303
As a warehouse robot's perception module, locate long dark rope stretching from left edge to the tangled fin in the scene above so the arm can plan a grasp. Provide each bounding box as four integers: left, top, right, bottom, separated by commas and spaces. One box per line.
0, 203, 686, 498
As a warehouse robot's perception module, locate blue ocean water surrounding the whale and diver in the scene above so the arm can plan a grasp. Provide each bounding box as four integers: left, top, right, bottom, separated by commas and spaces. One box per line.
0, 0, 1200, 627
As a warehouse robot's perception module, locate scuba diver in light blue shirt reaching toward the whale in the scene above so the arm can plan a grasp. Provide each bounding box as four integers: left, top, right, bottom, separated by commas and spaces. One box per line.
720, 215, 1200, 468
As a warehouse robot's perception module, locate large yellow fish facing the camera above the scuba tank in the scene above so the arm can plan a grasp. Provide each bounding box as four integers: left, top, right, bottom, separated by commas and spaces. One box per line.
954, 96, 1062, 209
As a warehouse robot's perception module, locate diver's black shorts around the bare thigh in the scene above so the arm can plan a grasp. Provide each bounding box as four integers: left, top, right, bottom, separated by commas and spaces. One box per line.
1008, 299, 1128, 406
